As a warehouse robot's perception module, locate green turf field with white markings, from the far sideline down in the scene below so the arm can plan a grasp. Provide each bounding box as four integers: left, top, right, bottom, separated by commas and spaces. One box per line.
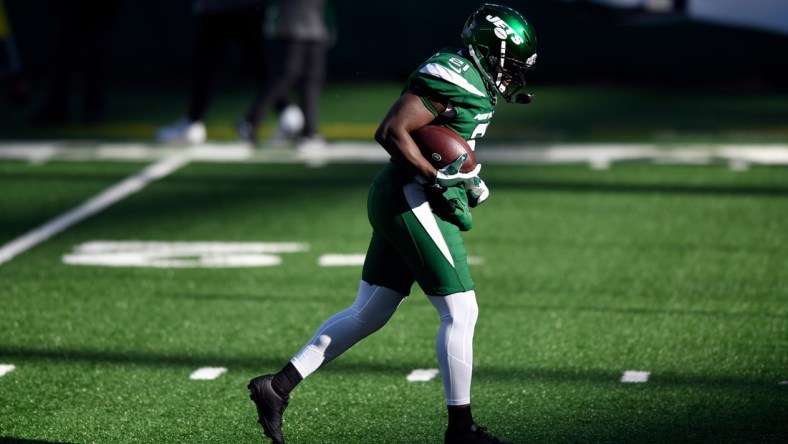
0, 141, 788, 444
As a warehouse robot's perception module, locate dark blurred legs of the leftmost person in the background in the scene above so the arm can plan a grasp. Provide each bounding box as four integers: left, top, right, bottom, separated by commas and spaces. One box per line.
31, 0, 121, 125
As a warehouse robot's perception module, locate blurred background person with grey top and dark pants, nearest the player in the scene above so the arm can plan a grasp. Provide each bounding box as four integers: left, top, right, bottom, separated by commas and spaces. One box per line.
236, 0, 336, 149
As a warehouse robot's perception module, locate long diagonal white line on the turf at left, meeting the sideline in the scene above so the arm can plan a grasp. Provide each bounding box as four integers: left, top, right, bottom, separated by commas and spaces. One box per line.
0, 154, 190, 265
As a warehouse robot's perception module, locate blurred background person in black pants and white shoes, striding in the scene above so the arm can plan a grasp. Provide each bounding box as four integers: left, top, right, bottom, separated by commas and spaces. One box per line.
156, 0, 303, 144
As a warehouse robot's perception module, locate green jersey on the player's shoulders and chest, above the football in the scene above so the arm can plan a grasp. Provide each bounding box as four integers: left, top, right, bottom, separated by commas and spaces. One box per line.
403, 48, 495, 149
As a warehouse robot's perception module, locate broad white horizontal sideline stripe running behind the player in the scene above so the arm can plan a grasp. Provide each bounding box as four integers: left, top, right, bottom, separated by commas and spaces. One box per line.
0, 141, 788, 169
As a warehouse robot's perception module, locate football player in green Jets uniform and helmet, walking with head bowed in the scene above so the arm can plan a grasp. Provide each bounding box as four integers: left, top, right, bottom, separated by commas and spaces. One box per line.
248, 4, 536, 443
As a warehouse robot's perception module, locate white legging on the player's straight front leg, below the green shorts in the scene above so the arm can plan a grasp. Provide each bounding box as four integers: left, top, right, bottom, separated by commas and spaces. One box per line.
428, 290, 479, 405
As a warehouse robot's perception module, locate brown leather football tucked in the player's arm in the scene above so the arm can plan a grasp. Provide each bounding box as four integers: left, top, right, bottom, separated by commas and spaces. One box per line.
410, 125, 476, 173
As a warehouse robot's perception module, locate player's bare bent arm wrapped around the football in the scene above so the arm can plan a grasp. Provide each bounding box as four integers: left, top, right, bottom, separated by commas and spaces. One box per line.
375, 92, 446, 182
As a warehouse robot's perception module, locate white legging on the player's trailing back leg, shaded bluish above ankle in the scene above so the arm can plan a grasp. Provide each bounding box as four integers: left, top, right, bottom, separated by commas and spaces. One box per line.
290, 281, 405, 378
